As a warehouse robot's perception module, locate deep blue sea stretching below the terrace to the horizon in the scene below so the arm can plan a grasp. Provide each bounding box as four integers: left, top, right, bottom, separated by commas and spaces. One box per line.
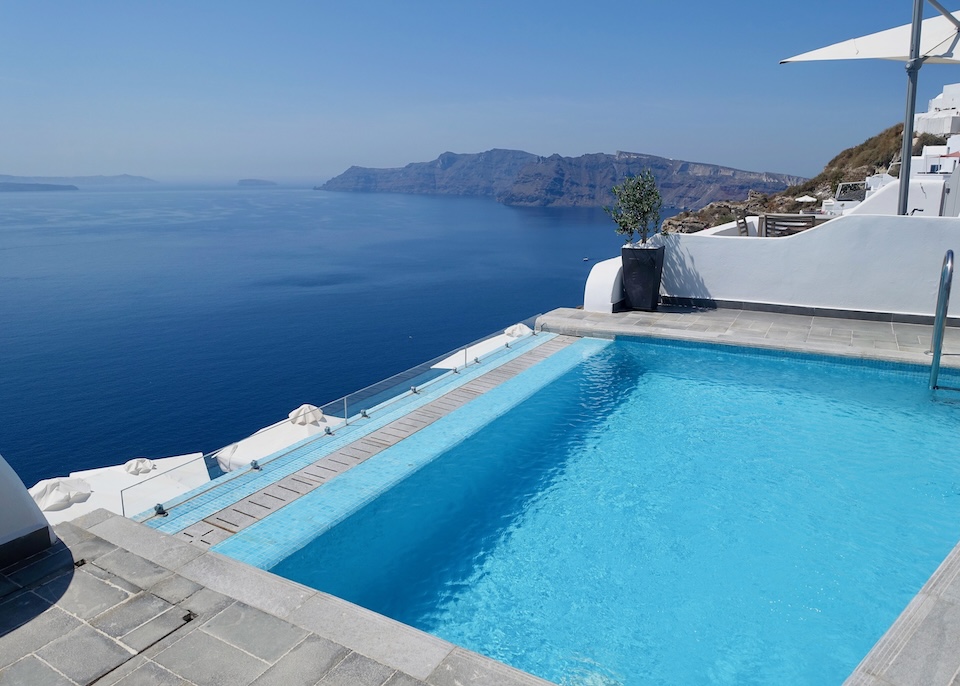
0, 187, 622, 486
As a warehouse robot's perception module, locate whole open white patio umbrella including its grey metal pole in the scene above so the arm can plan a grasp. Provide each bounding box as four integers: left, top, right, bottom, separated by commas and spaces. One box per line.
780, 0, 960, 214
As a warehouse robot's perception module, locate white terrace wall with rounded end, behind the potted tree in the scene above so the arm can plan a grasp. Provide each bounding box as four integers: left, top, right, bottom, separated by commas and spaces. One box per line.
584, 215, 960, 315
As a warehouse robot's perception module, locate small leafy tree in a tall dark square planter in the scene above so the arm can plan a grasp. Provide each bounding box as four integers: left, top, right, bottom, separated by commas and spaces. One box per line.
603, 169, 664, 312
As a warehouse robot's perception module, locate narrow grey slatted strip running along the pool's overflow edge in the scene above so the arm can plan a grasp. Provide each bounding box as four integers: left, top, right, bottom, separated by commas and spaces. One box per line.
176, 335, 577, 548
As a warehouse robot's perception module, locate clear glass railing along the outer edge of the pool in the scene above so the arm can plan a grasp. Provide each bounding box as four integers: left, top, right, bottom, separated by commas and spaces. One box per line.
120, 315, 540, 521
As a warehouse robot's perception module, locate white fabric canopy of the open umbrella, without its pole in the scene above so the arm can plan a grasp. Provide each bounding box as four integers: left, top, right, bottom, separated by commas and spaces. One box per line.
780, 12, 960, 64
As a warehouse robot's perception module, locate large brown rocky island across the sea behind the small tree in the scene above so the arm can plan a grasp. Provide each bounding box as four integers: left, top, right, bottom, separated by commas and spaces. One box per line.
319, 149, 805, 210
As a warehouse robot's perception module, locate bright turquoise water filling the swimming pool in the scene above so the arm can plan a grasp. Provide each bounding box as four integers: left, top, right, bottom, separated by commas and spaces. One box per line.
272, 341, 960, 684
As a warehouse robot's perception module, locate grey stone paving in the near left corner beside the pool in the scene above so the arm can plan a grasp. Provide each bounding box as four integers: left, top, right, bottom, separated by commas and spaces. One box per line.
0, 510, 547, 686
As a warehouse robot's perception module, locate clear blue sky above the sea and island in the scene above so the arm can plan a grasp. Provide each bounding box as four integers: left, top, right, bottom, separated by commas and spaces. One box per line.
0, 0, 960, 181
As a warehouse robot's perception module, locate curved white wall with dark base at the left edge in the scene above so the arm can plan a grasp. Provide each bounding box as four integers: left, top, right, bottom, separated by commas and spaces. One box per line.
0, 455, 56, 567
